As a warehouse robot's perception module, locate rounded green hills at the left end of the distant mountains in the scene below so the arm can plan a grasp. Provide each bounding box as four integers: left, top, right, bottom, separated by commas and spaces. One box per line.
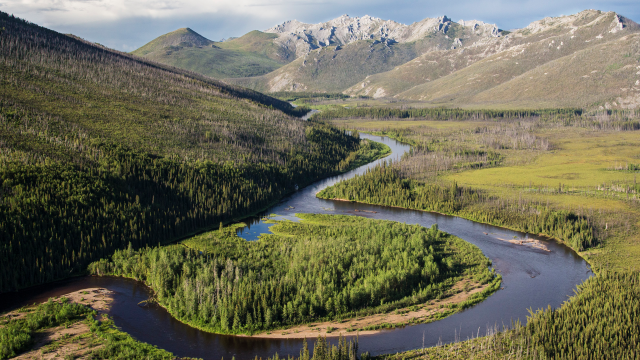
132, 28, 293, 78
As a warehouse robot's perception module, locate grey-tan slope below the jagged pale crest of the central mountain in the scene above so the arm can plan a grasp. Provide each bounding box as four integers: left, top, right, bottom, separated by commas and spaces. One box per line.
230, 18, 499, 96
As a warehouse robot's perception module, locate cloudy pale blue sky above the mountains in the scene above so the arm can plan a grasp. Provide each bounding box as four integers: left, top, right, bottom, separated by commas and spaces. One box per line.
0, 0, 640, 51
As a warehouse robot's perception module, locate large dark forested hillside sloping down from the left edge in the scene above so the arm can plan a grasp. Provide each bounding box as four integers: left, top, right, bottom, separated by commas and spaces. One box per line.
0, 13, 359, 291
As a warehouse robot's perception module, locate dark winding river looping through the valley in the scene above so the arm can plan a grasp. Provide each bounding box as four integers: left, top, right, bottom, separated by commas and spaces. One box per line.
0, 134, 592, 360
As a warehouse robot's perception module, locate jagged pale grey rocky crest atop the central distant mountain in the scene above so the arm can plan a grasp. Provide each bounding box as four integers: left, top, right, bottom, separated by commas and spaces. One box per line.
265, 15, 500, 57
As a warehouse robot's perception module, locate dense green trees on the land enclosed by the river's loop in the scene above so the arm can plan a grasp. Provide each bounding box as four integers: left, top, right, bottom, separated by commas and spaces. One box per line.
89, 214, 494, 333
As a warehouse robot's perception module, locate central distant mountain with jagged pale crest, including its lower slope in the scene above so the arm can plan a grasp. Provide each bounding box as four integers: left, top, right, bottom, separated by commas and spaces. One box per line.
227, 15, 502, 95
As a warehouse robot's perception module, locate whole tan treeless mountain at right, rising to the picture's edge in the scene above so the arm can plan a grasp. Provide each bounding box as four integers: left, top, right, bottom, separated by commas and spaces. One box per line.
345, 10, 640, 106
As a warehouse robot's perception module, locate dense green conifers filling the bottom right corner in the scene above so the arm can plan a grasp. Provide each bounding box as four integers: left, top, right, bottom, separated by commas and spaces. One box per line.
521, 271, 640, 359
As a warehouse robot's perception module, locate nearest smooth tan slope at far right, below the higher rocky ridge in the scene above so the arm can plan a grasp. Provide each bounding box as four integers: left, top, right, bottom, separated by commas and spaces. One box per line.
465, 33, 640, 109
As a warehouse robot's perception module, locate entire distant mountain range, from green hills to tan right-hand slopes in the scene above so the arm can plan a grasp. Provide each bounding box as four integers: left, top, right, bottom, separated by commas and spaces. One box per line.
134, 10, 640, 108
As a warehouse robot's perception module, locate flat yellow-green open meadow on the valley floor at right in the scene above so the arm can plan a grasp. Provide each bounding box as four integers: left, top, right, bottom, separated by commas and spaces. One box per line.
443, 130, 640, 270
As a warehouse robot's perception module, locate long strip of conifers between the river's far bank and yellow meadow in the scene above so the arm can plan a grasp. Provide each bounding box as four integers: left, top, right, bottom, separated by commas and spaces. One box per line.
317, 163, 597, 251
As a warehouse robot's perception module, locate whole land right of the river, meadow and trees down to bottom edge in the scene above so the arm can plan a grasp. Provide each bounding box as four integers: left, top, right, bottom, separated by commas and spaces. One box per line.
319, 112, 640, 359
